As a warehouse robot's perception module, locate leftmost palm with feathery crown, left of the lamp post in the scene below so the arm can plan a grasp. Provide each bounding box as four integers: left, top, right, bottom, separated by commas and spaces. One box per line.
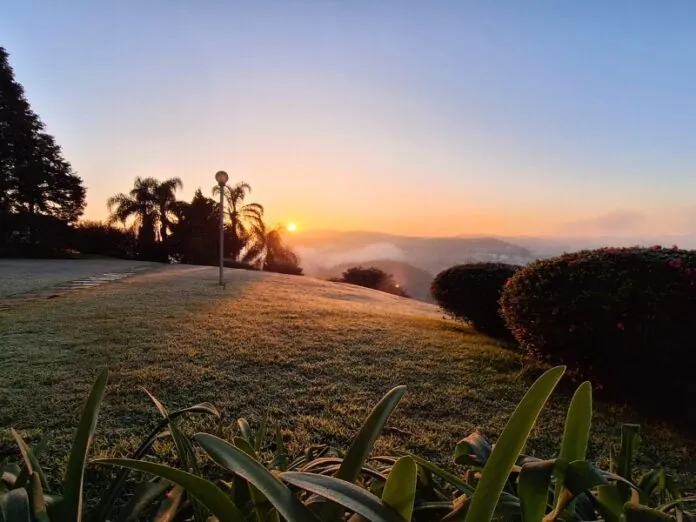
106, 177, 183, 240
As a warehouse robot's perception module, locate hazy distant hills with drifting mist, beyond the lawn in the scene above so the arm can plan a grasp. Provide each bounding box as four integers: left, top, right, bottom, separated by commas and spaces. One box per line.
289, 230, 535, 275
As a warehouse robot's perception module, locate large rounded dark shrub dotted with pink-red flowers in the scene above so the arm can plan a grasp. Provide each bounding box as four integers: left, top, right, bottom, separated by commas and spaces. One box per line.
501, 247, 696, 411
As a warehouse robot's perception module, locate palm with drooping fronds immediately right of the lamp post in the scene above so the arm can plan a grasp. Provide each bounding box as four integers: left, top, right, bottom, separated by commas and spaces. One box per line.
213, 181, 266, 261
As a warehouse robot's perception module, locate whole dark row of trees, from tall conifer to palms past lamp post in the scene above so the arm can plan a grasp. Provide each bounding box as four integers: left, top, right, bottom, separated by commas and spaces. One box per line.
0, 47, 302, 273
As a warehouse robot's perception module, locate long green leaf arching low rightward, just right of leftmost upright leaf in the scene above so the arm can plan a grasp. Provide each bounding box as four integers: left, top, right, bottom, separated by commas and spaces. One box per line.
94, 459, 244, 522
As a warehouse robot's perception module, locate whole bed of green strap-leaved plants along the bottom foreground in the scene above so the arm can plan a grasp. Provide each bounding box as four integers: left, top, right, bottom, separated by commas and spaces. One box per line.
0, 367, 696, 522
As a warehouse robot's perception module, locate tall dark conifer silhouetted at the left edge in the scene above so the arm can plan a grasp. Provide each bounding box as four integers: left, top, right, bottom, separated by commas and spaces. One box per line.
0, 47, 85, 244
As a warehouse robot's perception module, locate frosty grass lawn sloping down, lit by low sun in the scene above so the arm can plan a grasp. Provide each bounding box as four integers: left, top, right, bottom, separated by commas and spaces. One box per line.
0, 266, 696, 487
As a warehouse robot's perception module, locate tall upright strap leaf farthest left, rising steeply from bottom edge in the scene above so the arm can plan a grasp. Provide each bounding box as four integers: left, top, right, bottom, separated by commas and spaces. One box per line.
60, 368, 109, 522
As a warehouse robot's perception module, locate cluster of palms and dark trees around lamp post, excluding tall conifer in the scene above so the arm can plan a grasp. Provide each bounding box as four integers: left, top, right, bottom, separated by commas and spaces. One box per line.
102, 178, 302, 274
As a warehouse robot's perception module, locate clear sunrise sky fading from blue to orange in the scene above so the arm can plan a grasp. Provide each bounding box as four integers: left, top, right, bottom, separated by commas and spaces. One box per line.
0, 0, 696, 236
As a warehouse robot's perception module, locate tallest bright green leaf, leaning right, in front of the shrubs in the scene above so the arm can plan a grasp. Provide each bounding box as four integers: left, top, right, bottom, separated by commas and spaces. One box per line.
466, 366, 565, 522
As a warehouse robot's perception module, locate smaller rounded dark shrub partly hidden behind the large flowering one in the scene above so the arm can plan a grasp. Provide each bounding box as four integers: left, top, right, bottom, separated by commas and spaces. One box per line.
431, 263, 519, 337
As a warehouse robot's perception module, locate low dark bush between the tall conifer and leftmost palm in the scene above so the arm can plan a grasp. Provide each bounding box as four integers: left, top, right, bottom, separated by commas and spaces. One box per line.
73, 221, 136, 259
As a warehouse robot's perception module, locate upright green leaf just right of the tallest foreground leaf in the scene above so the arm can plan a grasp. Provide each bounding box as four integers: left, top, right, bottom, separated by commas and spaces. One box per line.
553, 381, 592, 505
